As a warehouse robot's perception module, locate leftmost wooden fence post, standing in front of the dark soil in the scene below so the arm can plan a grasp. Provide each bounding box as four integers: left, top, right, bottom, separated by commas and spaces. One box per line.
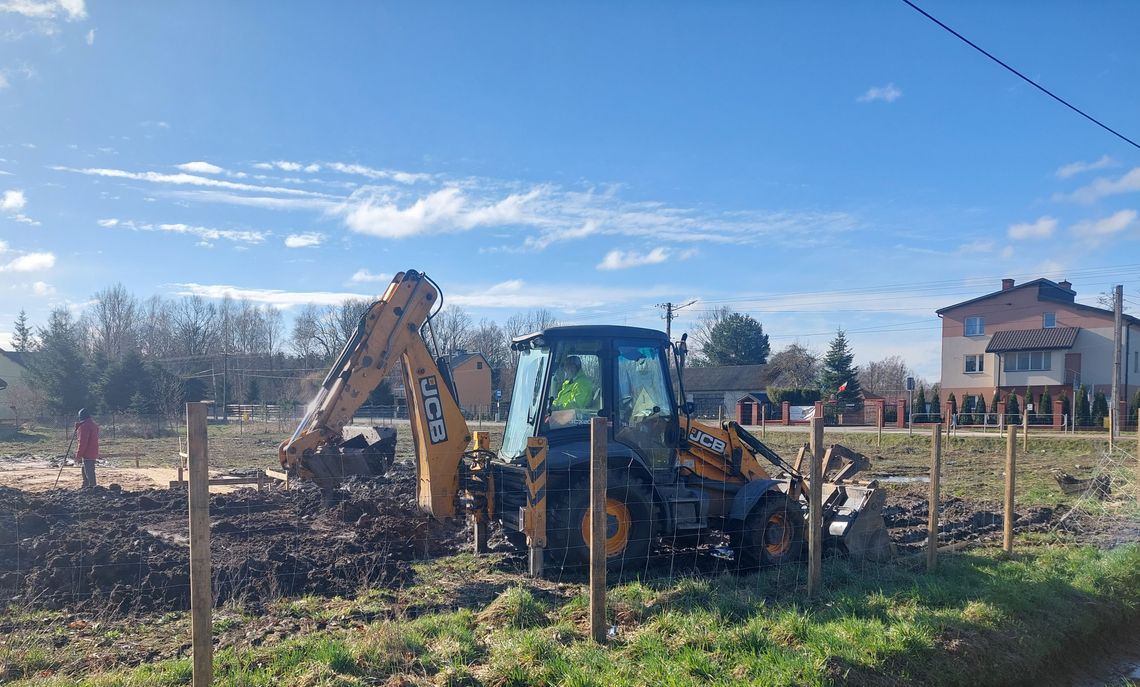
186, 403, 213, 687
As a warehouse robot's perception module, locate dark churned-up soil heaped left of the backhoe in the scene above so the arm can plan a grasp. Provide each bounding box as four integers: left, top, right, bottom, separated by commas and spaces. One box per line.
0, 466, 465, 614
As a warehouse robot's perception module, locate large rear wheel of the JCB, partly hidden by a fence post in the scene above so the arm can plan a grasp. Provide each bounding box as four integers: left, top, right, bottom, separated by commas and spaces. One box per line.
545, 469, 657, 574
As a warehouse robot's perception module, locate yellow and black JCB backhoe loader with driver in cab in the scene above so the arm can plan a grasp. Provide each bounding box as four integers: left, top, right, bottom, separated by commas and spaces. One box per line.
279, 270, 891, 570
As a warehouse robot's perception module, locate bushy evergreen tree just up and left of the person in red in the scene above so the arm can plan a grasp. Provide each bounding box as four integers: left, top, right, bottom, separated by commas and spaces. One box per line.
29, 308, 91, 416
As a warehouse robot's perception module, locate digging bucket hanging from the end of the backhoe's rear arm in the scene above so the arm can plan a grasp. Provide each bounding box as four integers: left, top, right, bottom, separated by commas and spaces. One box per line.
301, 426, 396, 498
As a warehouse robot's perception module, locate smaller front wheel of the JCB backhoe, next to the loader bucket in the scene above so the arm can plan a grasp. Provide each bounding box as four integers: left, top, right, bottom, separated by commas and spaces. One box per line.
736, 492, 807, 571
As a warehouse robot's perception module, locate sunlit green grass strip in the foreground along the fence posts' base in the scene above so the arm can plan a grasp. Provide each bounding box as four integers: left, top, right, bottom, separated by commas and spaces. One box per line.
11, 545, 1140, 687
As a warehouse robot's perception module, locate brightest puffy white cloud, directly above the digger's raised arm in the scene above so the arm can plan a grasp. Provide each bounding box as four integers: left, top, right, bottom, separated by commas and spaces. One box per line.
341, 187, 540, 238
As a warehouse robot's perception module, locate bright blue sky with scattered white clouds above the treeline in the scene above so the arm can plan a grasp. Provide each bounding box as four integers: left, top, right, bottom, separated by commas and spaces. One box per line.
0, 0, 1140, 381
